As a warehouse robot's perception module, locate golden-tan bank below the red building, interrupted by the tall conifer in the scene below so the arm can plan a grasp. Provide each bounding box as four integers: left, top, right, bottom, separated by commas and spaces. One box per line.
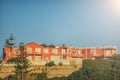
0, 60, 82, 78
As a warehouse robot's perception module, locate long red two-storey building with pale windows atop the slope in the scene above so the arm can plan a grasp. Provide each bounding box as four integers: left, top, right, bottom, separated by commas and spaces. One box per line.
3, 42, 117, 62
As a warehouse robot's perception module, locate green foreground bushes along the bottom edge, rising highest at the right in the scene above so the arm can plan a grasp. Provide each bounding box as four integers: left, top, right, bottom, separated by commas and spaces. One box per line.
0, 55, 120, 80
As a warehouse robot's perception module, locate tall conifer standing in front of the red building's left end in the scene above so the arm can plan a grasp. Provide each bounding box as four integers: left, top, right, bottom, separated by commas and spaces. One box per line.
15, 42, 31, 80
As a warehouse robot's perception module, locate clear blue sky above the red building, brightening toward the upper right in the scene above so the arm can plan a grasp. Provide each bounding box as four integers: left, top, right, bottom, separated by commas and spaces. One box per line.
0, 0, 120, 54
